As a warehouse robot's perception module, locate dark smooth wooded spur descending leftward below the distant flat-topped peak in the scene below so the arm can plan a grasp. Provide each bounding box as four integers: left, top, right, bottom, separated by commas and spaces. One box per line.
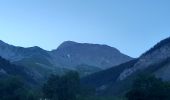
82, 59, 137, 88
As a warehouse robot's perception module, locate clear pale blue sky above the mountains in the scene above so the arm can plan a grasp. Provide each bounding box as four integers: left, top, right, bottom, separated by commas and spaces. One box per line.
0, 0, 170, 57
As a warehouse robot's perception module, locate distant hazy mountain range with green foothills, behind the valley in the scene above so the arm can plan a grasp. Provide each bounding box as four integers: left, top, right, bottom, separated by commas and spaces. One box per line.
0, 41, 132, 79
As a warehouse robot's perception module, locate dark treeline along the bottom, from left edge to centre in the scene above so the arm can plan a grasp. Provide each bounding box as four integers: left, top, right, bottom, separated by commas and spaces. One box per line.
0, 71, 94, 100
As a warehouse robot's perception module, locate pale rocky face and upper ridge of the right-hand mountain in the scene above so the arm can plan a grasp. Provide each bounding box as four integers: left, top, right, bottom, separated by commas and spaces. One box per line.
119, 38, 170, 80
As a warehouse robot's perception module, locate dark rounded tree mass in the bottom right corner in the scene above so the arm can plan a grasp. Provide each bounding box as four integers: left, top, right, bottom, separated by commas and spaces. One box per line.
126, 75, 170, 100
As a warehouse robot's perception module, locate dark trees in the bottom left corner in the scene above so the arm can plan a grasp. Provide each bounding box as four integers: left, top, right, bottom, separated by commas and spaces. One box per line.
0, 76, 37, 100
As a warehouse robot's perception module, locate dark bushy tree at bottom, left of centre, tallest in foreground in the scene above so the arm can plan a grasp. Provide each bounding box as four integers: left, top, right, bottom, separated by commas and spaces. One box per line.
43, 71, 80, 100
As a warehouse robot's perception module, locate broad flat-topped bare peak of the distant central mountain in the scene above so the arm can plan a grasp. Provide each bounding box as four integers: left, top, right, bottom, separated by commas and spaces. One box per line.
50, 41, 132, 69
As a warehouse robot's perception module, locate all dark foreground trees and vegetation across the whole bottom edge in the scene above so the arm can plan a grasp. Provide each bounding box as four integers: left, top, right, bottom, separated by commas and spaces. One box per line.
0, 72, 170, 100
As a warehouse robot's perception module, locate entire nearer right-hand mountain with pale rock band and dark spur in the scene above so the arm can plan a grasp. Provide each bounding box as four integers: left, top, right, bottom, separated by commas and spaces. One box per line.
81, 38, 170, 95
